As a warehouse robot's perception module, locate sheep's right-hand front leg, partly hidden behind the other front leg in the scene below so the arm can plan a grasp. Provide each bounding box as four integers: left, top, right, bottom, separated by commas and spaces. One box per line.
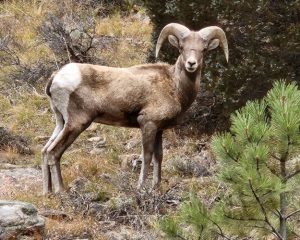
152, 131, 163, 188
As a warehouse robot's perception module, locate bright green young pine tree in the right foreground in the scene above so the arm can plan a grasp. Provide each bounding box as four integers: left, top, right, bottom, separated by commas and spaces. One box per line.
162, 81, 300, 240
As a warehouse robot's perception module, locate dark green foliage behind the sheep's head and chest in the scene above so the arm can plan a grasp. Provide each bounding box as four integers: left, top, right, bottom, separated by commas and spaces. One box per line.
144, 0, 300, 131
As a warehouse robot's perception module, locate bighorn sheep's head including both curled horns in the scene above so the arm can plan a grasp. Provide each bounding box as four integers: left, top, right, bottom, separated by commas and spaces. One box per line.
156, 23, 228, 72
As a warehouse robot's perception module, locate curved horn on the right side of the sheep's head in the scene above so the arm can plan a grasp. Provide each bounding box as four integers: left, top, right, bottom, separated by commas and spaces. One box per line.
198, 26, 229, 62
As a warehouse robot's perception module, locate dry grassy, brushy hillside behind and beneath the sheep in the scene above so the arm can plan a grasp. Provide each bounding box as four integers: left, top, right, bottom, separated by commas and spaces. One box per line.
0, 0, 216, 240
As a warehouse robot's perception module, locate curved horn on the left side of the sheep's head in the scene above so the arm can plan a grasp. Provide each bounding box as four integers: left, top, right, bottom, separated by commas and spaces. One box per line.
155, 23, 191, 58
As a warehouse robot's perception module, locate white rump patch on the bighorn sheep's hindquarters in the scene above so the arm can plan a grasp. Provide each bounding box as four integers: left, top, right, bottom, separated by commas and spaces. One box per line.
52, 63, 81, 92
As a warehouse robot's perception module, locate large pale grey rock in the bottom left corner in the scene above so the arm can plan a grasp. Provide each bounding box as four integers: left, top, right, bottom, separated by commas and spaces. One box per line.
0, 200, 45, 240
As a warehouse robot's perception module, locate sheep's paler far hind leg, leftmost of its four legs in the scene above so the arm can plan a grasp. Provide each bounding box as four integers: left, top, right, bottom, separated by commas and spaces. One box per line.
42, 107, 64, 195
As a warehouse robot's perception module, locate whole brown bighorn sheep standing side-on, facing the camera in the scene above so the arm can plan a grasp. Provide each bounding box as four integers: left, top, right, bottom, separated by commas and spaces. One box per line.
42, 23, 228, 194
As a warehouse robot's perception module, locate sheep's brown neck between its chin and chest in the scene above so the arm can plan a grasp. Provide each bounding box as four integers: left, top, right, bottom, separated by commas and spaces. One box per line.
174, 57, 201, 111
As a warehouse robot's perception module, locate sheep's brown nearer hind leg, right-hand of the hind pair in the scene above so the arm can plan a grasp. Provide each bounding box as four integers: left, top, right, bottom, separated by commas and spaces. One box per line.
47, 119, 91, 193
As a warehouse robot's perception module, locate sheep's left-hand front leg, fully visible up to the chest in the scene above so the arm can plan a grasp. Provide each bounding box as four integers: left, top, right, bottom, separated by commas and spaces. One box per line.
138, 121, 157, 189
